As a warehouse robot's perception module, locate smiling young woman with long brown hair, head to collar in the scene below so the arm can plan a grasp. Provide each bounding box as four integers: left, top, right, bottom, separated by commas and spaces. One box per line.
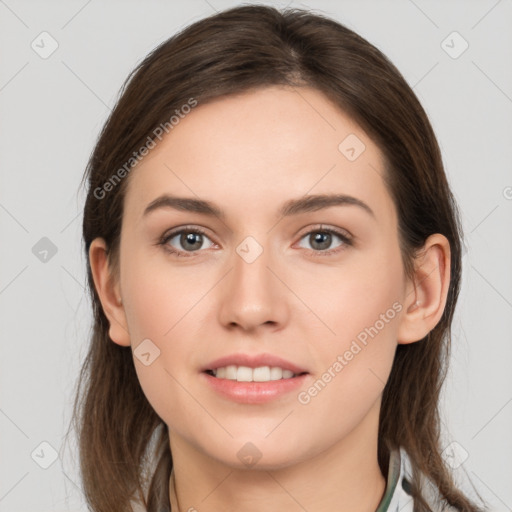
71, 6, 480, 512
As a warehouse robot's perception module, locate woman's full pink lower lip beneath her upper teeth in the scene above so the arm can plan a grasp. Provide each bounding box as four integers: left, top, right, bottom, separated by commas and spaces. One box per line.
201, 373, 308, 404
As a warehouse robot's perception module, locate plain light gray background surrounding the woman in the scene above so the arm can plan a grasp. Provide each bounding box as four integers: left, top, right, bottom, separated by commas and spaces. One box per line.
0, 0, 512, 512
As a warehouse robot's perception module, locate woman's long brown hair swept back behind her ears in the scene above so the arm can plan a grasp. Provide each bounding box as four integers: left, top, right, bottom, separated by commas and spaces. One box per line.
73, 5, 480, 512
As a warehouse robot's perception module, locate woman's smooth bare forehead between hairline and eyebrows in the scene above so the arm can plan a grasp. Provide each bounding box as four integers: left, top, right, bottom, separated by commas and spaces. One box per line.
122, 86, 392, 225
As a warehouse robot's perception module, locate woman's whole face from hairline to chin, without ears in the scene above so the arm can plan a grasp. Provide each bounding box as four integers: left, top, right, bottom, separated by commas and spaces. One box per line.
111, 87, 410, 468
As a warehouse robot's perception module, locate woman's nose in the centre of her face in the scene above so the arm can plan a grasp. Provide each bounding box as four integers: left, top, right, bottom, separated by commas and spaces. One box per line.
218, 239, 290, 331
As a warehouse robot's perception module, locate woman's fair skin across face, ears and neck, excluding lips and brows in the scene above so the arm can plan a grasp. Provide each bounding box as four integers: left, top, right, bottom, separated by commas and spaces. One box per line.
89, 87, 450, 512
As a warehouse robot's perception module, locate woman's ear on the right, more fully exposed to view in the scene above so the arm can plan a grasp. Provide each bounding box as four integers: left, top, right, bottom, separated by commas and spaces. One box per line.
398, 233, 450, 344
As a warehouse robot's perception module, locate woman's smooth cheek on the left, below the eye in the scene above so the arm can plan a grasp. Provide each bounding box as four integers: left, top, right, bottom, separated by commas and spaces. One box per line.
122, 252, 215, 422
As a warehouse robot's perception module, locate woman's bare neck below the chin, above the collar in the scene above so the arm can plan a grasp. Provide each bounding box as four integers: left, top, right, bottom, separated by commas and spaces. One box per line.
170, 402, 386, 512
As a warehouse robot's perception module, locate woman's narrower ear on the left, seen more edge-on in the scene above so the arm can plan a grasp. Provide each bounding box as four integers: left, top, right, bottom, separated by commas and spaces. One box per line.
89, 238, 130, 347
